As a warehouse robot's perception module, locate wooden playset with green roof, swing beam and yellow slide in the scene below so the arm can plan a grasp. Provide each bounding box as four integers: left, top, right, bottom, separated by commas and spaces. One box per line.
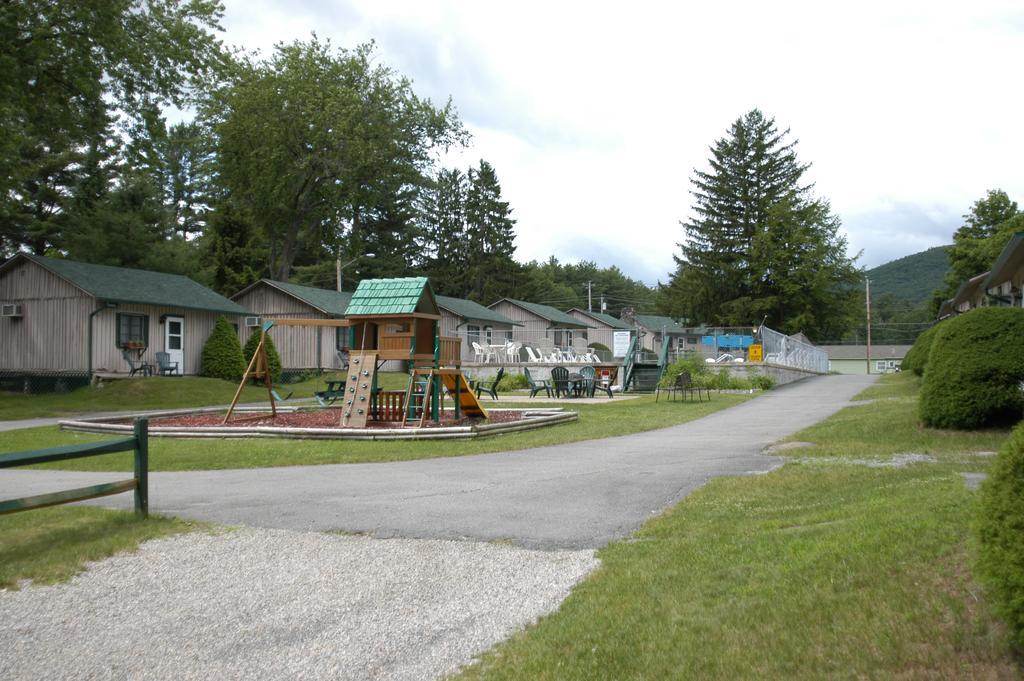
222, 278, 488, 428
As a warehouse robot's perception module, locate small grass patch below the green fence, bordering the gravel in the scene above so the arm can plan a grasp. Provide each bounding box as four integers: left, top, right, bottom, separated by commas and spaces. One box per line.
0, 506, 205, 589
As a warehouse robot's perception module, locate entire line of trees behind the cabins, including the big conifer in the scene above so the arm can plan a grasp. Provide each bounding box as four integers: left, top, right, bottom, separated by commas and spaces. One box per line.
0, 0, 884, 338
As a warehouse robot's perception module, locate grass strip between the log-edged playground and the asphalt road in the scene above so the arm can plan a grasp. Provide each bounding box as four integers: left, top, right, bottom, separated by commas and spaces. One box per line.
0, 394, 751, 471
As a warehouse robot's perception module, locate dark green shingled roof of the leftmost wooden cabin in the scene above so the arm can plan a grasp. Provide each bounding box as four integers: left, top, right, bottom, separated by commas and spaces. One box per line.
14, 253, 251, 314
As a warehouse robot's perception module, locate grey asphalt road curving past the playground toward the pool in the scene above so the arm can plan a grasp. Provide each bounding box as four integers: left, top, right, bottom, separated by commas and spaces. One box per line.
0, 376, 876, 549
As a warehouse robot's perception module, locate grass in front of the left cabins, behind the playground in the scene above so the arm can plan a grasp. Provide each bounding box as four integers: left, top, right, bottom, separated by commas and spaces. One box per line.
0, 372, 409, 421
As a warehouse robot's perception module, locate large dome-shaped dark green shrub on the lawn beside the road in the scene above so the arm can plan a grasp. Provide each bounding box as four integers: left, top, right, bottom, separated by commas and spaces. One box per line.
920, 307, 1024, 430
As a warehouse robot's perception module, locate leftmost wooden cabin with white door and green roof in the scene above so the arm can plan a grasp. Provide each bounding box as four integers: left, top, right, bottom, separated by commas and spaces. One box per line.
0, 253, 252, 380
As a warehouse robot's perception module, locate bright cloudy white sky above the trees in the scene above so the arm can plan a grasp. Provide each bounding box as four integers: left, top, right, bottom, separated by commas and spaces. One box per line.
214, 0, 1024, 285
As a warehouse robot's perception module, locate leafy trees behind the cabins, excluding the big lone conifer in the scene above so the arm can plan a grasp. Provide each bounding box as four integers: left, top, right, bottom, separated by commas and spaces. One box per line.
0, 0, 651, 311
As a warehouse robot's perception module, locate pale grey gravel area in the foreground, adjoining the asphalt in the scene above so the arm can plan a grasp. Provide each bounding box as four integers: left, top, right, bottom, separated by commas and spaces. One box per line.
0, 528, 598, 681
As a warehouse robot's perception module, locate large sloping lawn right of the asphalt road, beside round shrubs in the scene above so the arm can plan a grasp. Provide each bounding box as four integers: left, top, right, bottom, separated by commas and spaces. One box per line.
462, 376, 1022, 680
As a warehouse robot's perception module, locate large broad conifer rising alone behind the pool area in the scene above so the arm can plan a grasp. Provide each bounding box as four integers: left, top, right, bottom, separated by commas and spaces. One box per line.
658, 110, 857, 336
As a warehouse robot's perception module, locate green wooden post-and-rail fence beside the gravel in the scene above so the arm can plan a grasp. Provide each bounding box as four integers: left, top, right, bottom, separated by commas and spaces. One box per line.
0, 419, 150, 518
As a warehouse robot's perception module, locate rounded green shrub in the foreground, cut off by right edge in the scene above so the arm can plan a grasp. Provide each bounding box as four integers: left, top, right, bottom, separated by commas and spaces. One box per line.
977, 419, 1024, 649
